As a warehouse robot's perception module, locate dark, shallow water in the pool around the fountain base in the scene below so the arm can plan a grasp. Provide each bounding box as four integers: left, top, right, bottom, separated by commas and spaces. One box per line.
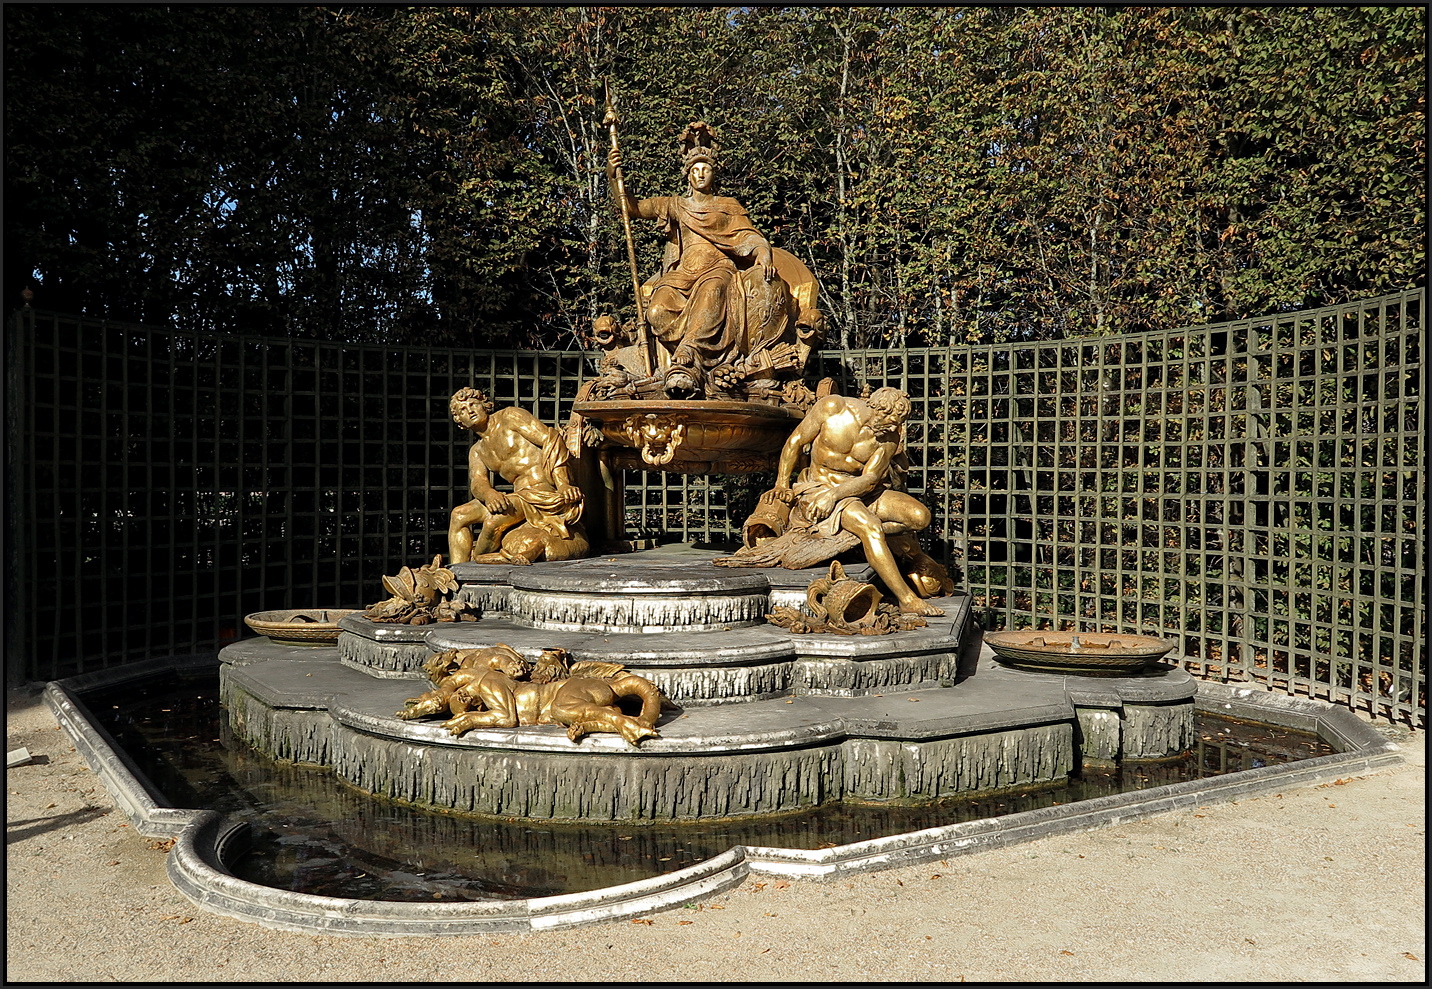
90, 676, 1332, 902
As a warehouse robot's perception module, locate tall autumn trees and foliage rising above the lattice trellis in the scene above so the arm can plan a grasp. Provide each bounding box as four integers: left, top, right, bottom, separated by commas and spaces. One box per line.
4, 4, 1426, 348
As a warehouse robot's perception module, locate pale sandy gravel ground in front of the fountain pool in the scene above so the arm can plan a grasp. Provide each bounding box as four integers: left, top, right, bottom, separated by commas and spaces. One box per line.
6, 690, 1426, 982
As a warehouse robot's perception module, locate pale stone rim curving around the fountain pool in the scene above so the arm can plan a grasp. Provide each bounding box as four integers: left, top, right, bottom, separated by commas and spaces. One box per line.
44, 654, 1402, 936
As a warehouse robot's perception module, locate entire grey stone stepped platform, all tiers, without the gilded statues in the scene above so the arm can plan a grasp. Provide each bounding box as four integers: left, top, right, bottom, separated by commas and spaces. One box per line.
221, 547, 1194, 822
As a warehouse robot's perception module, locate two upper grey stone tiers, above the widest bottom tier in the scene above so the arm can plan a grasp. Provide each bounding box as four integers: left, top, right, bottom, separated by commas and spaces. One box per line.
338, 545, 969, 706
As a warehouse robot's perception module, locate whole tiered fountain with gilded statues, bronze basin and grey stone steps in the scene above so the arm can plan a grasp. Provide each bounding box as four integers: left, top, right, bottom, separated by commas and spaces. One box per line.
223, 113, 1193, 822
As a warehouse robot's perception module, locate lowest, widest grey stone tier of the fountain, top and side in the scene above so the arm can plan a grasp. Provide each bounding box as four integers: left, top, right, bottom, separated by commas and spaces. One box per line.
221, 633, 1194, 822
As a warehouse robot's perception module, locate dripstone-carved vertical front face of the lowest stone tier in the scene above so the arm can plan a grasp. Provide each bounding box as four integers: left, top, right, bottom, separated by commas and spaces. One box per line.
225, 687, 1074, 822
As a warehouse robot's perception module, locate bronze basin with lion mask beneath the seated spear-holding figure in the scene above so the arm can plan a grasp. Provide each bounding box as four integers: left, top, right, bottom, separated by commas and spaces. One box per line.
573, 399, 800, 474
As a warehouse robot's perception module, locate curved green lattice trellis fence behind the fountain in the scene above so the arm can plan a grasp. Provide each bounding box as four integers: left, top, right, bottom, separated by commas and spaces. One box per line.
6, 291, 1426, 721
